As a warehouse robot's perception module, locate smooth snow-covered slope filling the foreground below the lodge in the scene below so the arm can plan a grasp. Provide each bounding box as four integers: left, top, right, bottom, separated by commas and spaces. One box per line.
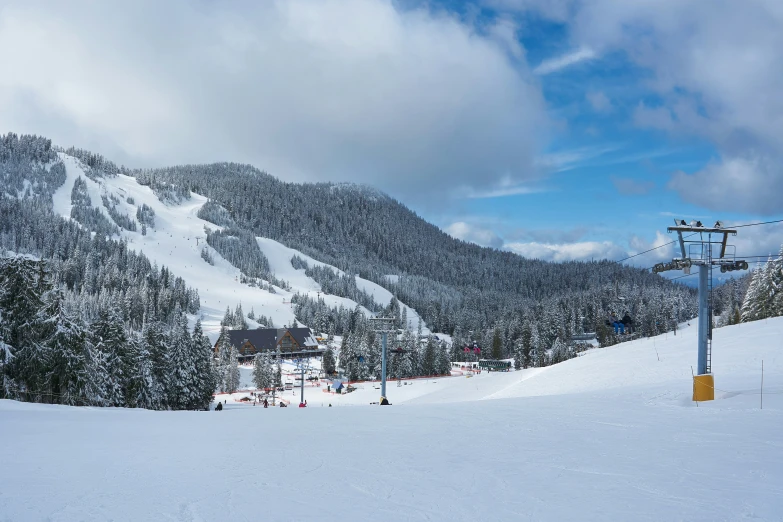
0, 318, 783, 522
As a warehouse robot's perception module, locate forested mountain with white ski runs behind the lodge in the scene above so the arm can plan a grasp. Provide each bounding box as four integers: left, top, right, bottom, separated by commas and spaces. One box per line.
0, 134, 696, 356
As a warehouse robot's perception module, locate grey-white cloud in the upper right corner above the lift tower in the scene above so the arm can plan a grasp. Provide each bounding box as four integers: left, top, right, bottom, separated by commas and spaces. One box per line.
568, 0, 783, 213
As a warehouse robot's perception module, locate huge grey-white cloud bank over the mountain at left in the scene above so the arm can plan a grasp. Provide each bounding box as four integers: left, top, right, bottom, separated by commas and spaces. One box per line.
0, 0, 548, 200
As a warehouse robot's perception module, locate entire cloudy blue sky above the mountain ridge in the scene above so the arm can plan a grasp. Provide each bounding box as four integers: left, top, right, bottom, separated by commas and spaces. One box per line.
0, 0, 783, 278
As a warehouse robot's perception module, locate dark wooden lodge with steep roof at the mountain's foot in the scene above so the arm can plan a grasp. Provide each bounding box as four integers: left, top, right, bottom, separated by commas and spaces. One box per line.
214, 328, 325, 361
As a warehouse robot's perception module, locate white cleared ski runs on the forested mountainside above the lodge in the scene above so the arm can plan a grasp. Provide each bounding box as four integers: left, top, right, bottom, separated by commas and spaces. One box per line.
53, 153, 428, 341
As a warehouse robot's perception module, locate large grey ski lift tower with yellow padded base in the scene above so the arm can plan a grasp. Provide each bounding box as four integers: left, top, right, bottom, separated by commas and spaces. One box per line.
653, 219, 748, 401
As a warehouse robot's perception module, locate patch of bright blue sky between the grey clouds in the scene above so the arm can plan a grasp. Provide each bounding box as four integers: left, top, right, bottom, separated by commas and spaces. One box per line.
410, 2, 783, 275
